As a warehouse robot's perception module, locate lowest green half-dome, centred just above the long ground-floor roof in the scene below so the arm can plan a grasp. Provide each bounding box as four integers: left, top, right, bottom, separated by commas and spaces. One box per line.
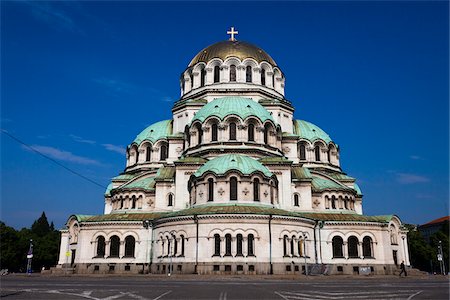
194, 154, 273, 177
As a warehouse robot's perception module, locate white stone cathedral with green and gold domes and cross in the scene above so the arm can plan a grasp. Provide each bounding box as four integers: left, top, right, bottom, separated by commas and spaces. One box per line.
55, 27, 410, 275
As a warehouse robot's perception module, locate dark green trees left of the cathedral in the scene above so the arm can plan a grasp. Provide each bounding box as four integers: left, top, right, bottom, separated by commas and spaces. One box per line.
0, 212, 60, 272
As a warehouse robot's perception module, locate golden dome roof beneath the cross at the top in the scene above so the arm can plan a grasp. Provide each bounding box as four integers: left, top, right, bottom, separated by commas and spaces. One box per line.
189, 40, 277, 67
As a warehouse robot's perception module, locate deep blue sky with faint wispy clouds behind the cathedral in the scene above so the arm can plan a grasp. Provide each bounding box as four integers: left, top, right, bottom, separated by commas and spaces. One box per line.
0, 1, 449, 228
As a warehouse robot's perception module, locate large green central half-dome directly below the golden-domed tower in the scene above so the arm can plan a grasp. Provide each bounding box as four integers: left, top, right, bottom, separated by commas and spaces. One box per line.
192, 97, 275, 123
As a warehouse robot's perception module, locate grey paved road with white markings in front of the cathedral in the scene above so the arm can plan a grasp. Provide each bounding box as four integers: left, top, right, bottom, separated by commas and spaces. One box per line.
1, 275, 449, 300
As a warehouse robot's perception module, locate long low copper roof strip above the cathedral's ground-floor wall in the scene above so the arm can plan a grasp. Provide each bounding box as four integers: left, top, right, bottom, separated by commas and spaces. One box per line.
72, 204, 392, 223
